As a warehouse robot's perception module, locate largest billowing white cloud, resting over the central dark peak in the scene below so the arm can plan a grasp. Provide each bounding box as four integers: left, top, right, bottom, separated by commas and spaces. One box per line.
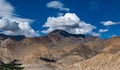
42, 13, 97, 35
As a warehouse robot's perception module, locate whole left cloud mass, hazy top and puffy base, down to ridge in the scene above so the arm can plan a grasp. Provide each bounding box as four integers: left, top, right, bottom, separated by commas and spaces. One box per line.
0, 0, 38, 37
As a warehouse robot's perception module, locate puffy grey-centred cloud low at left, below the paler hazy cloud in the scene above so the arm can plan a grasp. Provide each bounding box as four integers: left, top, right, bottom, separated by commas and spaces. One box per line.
0, 17, 38, 37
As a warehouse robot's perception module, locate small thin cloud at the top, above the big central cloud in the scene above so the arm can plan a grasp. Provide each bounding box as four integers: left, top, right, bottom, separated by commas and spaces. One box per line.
47, 1, 70, 11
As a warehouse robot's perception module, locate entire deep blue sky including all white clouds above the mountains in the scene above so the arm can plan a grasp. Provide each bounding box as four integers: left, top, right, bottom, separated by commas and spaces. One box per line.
0, 0, 120, 38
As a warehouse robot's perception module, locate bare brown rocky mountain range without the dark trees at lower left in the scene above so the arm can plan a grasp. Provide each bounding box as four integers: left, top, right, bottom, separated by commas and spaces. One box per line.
0, 30, 120, 70
